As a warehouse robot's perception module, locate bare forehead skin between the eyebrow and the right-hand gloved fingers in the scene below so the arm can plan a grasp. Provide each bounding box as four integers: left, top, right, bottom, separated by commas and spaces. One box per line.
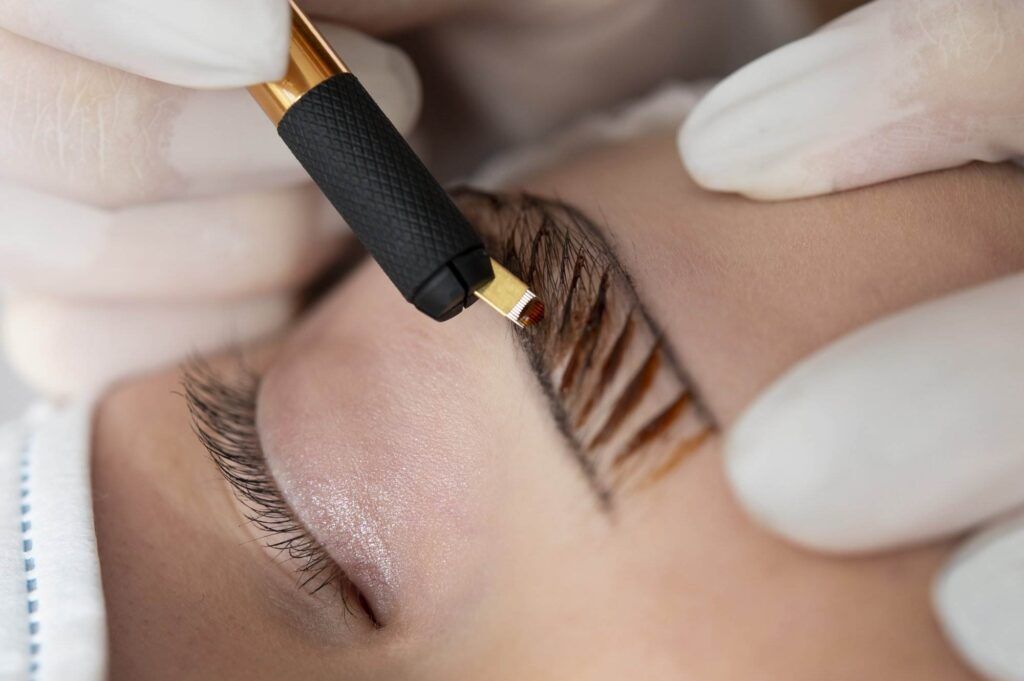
524, 131, 1024, 425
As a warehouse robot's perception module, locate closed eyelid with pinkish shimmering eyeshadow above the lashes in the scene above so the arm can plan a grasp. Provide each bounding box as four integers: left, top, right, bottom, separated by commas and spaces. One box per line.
258, 352, 479, 622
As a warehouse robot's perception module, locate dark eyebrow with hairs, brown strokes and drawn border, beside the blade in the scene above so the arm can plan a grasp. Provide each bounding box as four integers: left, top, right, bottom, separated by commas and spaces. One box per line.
453, 187, 719, 503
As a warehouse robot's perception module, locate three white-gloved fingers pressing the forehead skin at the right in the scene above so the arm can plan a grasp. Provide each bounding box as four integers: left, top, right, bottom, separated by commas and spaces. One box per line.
680, 0, 1024, 681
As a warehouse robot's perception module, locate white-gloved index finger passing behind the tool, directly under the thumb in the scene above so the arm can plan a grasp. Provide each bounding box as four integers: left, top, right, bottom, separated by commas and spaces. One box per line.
0, 26, 420, 207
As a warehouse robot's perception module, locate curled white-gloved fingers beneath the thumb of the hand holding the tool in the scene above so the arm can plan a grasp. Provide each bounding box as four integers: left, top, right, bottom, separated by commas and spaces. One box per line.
0, 18, 419, 396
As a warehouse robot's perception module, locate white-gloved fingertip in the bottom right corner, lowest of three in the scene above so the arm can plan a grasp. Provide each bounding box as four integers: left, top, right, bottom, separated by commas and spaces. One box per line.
932, 515, 1024, 681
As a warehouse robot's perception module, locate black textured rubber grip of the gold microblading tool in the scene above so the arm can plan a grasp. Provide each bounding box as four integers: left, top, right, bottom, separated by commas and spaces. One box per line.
278, 74, 494, 318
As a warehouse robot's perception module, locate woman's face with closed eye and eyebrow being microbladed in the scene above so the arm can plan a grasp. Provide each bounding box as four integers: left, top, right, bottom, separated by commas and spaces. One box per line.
93, 130, 1024, 681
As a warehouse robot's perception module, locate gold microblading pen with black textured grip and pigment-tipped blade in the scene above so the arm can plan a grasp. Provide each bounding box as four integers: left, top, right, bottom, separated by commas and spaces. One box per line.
250, 0, 544, 327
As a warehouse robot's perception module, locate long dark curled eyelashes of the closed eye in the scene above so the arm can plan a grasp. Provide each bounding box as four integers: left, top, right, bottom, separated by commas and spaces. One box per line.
182, 358, 381, 629
